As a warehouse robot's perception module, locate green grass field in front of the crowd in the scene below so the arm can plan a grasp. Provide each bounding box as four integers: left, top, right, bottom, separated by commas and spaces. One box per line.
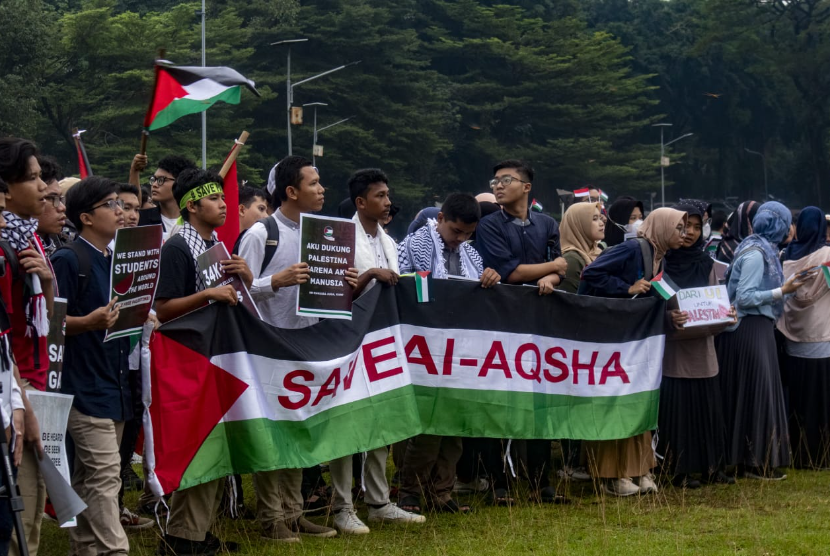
39, 462, 830, 556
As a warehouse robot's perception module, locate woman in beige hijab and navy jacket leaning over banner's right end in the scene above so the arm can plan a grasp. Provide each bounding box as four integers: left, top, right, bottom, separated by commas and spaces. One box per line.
579, 208, 686, 496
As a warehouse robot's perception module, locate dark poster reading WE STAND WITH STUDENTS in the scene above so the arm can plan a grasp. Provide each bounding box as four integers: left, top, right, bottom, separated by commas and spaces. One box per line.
104, 224, 162, 342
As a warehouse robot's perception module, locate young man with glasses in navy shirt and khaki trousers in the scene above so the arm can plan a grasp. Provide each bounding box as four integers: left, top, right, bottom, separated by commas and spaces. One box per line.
52, 176, 133, 555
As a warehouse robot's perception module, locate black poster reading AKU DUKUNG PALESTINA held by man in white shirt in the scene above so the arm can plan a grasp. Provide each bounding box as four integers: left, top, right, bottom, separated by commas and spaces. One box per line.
297, 214, 355, 320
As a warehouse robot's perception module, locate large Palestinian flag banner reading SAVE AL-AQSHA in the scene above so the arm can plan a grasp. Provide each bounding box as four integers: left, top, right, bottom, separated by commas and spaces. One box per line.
144, 278, 665, 494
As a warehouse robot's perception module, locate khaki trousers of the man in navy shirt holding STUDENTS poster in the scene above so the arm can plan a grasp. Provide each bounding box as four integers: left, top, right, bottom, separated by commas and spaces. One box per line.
67, 407, 130, 556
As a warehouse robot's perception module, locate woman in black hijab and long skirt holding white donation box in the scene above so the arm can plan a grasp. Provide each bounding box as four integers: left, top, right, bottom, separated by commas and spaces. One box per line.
657, 199, 735, 488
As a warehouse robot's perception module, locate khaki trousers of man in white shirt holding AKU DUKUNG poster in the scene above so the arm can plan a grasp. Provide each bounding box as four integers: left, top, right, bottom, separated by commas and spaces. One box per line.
254, 469, 303, 527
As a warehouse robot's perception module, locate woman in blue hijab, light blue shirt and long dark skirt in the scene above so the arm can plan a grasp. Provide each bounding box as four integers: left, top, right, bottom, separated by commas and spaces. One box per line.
716, 201, 815, 480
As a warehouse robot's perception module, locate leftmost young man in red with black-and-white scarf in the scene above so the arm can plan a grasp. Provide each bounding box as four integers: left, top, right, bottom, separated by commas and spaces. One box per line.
0, 138, 54, 555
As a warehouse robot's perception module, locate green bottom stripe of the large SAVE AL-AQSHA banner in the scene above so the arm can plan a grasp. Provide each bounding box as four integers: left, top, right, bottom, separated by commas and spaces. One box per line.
179, 386, 660, 489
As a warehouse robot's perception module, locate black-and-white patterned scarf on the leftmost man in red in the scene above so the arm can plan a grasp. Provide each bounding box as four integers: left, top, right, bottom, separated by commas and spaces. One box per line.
0, 211, 51, 338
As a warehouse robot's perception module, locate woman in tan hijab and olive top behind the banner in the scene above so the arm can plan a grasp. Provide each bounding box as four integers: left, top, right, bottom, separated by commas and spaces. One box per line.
557, 203, 605, 293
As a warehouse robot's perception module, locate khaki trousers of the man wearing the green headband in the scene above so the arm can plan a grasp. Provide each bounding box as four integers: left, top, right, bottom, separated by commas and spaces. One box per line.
167, 479, 225, 542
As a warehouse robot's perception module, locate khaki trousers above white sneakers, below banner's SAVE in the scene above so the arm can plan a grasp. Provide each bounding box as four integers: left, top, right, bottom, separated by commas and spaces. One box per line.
329, 446, 389, 512
